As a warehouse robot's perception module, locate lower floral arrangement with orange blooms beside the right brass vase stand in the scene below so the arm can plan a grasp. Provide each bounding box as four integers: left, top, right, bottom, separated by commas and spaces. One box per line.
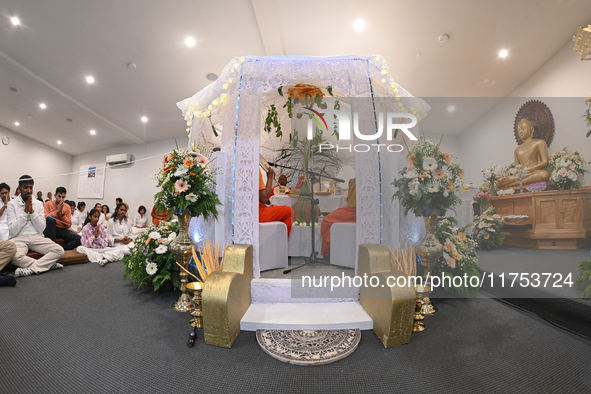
433, 218, 481, 294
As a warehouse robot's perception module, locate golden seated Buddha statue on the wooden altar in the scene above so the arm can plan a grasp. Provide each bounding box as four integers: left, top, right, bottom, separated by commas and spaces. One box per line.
496, 118, 550, 190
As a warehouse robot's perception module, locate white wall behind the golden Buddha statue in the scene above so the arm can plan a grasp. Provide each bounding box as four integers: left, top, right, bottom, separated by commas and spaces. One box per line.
458, 41, 591, 185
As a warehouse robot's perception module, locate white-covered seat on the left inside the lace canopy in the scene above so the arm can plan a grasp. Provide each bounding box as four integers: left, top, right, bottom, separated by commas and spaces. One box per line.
259, 222, 289, 272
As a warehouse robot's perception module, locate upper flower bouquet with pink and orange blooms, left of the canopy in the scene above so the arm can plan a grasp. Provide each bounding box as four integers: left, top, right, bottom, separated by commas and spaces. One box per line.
154, 144, 221, 219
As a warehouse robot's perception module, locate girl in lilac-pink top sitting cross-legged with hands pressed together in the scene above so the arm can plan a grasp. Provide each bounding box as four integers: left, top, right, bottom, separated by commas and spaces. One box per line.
76, 209, 124, 267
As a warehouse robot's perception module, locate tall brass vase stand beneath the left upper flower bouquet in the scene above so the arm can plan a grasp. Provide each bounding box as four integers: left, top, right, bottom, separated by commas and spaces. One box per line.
170, 209, 195, 312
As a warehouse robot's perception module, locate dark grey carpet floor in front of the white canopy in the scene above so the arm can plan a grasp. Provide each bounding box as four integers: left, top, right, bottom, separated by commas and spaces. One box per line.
0, 263, 591, 393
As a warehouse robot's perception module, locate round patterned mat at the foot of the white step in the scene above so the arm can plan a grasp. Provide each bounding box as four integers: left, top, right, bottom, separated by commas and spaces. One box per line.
257, 329, 361, 366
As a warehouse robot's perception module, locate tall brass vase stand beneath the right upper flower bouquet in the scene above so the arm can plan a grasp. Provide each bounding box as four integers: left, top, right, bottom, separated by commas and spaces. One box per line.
413, 209, 443, 332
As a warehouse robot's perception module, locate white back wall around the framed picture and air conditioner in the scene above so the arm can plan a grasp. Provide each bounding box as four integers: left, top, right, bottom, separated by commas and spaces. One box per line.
68, 138, 189, 217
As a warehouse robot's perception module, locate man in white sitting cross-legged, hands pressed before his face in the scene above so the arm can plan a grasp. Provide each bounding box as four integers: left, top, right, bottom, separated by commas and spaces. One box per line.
7, 175, 64, 277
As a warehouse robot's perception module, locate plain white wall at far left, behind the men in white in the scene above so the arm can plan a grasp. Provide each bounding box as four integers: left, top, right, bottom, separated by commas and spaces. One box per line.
0, 126, 73, 197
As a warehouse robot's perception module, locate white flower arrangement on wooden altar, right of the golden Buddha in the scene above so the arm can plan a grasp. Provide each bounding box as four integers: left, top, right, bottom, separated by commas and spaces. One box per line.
548, 148, 587, 190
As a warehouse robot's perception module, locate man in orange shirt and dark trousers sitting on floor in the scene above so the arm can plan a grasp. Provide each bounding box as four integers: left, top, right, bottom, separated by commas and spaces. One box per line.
43, 186, 80, 250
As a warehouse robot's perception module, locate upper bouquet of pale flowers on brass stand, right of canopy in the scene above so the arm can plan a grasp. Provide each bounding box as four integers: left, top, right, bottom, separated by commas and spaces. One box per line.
392, 137, 464, 216
